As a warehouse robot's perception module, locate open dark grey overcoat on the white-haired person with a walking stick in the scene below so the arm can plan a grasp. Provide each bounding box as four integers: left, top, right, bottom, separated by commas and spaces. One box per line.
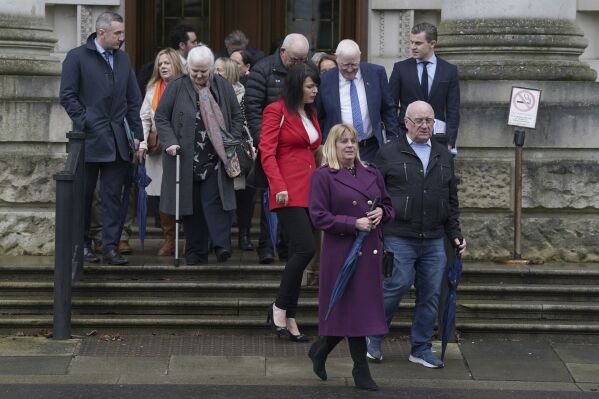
154, 75, 243, 215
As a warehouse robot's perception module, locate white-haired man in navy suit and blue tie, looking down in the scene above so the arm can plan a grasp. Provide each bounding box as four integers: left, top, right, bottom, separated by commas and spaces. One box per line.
316, 39, 399, 162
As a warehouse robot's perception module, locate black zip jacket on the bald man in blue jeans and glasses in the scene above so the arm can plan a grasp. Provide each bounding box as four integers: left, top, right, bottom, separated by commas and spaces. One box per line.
375, 135, 462, 241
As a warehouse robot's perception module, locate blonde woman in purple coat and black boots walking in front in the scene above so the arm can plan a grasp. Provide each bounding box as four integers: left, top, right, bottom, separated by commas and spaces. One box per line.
308, 125, 395, 390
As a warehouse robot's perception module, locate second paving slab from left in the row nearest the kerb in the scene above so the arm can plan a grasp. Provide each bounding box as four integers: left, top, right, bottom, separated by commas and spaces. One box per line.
69, 356, 169, 376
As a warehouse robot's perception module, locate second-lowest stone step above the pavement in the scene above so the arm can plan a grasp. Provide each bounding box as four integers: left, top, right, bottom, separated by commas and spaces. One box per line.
0, 296, 599, 322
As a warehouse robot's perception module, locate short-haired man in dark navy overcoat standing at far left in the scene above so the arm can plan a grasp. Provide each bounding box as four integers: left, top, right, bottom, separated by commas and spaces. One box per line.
60, 12, 145, 265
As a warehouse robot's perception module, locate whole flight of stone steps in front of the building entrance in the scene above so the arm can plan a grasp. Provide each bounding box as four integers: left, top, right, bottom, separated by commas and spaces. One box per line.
0, 237, 599, 335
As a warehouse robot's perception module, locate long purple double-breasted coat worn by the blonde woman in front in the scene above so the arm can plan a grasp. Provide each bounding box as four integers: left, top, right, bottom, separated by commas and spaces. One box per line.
310, 163, 395, 337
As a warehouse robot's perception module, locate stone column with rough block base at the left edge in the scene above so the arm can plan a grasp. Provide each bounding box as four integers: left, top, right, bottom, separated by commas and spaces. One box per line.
0, 0, 71, 255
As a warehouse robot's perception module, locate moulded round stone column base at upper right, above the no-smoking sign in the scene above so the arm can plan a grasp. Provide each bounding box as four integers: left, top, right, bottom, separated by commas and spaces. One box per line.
437, 0, 597, 80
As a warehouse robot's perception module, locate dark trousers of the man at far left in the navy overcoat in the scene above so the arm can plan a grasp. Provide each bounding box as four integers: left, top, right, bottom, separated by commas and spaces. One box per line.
83, 159, 131, 252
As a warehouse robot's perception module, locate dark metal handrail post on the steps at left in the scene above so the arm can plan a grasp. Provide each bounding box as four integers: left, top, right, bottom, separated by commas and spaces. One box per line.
52, 131, 85, 339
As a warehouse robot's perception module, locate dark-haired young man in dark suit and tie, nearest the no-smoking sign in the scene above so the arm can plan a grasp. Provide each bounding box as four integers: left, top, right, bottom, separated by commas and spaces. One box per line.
389, 22, 460, 152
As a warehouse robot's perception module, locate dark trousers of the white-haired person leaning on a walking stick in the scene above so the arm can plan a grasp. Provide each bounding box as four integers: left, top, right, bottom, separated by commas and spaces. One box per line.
182, 171, 232, 262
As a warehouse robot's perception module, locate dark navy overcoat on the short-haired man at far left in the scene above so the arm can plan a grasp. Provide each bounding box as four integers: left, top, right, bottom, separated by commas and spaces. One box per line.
60, 33, 144, 162
